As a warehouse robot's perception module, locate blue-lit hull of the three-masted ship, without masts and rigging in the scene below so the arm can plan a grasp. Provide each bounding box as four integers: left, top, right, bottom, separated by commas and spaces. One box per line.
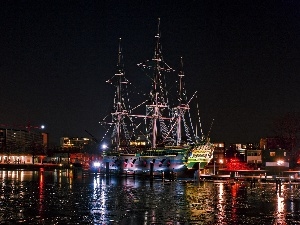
94, 145, 210, 178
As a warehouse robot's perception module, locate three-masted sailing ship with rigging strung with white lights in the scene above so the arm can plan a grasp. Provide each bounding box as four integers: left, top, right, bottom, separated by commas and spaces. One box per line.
96, 20, 213, 178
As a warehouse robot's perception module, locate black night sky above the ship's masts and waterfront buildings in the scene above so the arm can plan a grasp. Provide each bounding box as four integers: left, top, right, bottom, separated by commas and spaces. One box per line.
0, 0, 300, 146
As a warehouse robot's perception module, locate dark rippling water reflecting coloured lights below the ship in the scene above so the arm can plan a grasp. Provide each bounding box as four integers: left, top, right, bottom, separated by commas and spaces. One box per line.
0, 170, 300, 225
